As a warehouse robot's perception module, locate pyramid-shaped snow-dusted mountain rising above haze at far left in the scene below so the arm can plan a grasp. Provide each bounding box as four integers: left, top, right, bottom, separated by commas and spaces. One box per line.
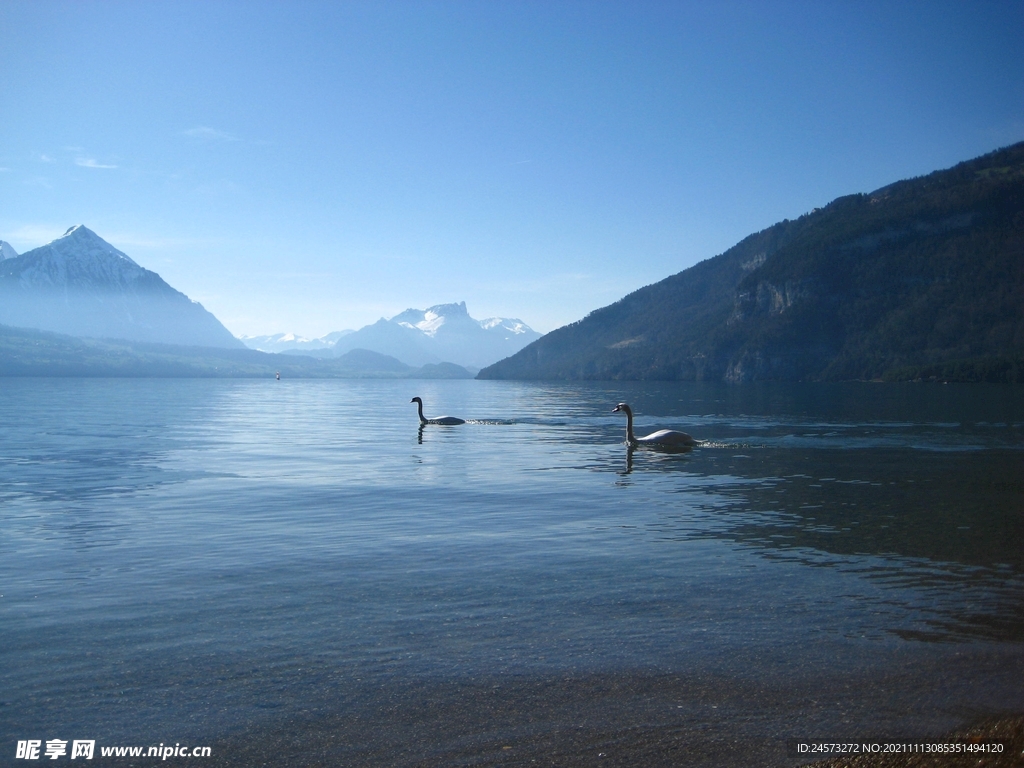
0, 225, 245, 348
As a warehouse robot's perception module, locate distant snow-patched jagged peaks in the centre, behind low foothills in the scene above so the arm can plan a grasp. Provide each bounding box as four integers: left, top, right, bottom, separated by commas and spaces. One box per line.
242, 301, 541, 369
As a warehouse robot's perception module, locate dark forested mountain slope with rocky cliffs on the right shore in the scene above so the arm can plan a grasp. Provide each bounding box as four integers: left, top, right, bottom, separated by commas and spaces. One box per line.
479, 142, 1024, 382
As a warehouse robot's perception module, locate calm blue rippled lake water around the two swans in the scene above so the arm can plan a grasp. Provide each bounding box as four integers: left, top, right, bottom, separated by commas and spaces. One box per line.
0, 379, 1024, 766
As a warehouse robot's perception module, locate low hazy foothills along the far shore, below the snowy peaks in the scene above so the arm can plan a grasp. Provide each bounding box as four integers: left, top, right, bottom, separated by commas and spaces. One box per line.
0, 326, 472, 379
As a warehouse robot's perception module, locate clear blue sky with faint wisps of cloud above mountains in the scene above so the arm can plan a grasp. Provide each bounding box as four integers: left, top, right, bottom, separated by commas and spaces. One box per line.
0, 0, 1024, 338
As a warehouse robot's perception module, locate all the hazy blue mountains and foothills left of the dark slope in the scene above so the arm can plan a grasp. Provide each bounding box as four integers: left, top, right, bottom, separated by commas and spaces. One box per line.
0, 225, 540, 378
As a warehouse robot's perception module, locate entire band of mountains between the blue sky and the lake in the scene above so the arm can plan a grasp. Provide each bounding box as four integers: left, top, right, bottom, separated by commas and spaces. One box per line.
9, 142, 1024, 382
